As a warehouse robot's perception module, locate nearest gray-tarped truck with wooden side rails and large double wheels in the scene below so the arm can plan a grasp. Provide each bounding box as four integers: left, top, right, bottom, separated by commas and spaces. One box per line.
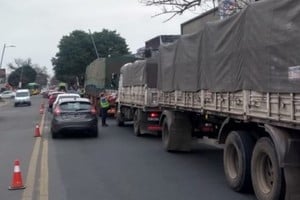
157, 0, 300, 200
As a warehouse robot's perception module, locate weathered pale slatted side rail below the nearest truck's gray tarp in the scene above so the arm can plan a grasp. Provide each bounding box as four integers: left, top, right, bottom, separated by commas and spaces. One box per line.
158, 90, 300, 129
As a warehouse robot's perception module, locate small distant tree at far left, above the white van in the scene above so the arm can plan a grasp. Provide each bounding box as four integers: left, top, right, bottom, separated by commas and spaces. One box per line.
8, 58, 37, 87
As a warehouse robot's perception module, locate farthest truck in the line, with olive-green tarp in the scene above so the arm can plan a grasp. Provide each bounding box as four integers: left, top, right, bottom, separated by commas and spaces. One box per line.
84, 55, 136, 116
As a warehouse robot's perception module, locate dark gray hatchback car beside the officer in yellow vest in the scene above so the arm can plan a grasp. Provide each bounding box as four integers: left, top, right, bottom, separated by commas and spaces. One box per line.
51, 97, 98, 138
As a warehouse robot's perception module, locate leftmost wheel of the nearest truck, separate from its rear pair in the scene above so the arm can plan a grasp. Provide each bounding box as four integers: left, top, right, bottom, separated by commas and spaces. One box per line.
162, 111, 192, 152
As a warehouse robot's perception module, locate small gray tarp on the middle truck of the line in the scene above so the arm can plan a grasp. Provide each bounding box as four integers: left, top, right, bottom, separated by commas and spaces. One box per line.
121, 58, 157, 88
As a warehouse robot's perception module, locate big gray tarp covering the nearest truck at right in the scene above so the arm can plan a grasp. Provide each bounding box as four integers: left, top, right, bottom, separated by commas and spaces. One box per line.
158, 0, 300, 92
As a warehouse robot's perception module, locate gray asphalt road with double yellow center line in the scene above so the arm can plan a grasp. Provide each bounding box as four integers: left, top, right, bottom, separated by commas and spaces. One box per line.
0, 97, 256, 200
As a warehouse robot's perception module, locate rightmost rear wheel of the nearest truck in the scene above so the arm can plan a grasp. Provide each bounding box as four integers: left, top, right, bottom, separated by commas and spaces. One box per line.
251, 137, 284, 200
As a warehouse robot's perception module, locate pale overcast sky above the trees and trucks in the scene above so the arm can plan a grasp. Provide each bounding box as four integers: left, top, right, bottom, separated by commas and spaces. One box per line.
0, 0, 216, 75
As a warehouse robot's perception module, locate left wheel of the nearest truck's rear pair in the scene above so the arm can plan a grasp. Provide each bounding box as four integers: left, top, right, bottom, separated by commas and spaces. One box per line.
223, 131, 255, 192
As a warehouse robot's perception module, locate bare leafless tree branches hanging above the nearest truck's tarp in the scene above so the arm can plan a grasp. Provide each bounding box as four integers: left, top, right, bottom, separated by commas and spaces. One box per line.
139, 0, 257, 21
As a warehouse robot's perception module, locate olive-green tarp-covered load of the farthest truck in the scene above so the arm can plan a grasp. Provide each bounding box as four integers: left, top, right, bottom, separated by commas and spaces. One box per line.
84, 56, 136, 96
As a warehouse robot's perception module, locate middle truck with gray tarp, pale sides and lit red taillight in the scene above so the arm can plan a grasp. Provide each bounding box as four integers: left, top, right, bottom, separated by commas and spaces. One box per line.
116, 58, 161, 136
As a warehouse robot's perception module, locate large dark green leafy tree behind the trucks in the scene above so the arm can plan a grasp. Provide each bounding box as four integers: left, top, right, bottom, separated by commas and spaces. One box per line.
51, 29, 129, 85
